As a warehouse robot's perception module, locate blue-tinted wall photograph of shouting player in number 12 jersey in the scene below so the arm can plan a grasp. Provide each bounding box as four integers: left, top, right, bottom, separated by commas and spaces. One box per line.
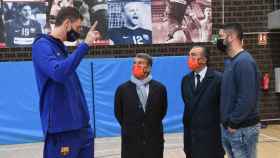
108, 0, 152, 45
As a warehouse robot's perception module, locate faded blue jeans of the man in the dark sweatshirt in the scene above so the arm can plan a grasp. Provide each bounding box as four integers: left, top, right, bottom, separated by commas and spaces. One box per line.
221, 124, 260, 158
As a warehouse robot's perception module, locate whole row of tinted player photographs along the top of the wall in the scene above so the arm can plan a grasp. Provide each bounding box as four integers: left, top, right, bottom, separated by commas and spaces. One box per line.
0, 0, 212, 48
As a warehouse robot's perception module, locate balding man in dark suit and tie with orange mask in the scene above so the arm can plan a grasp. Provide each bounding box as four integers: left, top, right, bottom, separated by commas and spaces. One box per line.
181, 46, 224, 158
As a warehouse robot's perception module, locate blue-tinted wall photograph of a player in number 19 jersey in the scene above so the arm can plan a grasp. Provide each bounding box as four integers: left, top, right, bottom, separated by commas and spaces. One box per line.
2, 0, 47, 47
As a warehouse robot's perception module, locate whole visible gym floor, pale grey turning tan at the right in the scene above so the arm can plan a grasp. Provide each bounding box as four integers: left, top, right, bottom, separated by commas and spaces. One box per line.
0, 125, 280, 158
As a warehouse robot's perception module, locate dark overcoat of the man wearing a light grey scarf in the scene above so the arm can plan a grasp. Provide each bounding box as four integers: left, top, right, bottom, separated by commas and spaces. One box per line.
115, 80, 167, 158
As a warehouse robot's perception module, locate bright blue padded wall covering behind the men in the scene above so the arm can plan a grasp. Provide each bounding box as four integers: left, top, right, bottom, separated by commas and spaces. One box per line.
0, 57, 189, 144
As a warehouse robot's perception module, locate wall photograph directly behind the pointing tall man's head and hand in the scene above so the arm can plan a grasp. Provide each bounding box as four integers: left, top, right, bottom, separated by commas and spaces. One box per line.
47, 0, 109, 45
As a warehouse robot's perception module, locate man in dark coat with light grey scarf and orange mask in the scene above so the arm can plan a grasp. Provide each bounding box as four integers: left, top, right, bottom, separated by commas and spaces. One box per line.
115, 53, 167, 158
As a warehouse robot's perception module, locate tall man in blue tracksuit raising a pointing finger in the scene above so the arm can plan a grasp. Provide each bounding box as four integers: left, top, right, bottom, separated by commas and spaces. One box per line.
32, 7, 98, 158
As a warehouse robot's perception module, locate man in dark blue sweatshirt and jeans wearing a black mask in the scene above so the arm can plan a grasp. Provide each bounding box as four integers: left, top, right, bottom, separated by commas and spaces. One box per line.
217, 24, 260, 158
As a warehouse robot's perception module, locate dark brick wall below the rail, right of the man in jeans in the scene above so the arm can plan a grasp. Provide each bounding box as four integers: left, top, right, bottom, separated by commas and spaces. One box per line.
245, 34, 280, 118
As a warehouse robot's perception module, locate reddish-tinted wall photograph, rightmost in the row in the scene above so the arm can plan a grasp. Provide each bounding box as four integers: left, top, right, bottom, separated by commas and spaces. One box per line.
152, 0, 212, 44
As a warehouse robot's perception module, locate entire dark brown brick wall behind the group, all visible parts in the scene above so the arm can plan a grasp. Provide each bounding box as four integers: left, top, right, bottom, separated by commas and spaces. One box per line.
0, 0, 280, 119
